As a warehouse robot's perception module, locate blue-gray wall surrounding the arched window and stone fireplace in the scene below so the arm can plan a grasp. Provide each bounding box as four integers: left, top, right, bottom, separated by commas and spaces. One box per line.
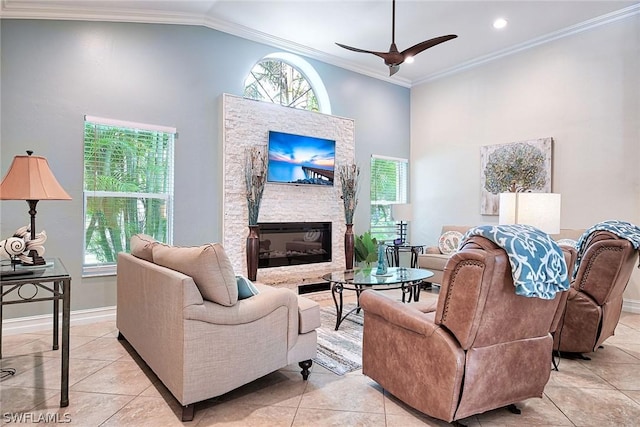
0, 20, 410, 318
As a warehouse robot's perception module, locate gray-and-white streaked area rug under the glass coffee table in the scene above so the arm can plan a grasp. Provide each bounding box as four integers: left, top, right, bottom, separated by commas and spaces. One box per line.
314, 304, 363, 375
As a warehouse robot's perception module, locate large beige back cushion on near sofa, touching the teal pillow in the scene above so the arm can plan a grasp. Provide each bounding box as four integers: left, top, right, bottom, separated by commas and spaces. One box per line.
153, 243, 238, 307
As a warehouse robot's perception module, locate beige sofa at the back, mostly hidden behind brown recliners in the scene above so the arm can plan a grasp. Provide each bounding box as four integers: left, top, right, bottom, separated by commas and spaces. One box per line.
418, 225, 585, 285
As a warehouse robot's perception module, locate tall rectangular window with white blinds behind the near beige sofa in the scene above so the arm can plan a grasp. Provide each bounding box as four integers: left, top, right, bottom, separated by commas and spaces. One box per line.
83, 116, 176, 275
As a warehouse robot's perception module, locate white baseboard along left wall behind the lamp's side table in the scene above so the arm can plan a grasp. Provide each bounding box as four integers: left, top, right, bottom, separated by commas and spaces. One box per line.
2, 306, 116, 335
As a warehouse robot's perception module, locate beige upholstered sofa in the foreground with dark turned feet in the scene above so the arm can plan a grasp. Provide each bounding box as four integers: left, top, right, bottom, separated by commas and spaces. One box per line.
117, 237, 320, 421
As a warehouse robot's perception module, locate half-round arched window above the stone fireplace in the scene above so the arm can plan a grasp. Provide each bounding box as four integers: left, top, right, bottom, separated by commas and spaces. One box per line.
244, 53, 331, 114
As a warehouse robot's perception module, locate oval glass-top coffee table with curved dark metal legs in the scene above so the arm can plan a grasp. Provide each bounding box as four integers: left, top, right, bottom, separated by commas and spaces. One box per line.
322, 267, 433, 331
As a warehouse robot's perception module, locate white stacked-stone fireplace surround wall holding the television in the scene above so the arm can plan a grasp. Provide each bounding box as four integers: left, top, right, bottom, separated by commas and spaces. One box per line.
221, 94, 355, 286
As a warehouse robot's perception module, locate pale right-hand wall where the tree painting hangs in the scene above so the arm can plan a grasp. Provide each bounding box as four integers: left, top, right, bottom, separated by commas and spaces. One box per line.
411, 14, 640, 300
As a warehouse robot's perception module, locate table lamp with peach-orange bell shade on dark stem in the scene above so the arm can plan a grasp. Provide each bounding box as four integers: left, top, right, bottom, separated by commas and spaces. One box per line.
0, 151, 71, 265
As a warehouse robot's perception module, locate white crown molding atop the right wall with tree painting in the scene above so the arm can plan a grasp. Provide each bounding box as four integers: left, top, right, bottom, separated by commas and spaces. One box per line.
412, 3, 640, 86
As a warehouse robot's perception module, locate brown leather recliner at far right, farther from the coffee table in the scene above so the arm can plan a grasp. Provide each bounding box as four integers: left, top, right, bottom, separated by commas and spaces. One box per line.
554, 231, 638, 353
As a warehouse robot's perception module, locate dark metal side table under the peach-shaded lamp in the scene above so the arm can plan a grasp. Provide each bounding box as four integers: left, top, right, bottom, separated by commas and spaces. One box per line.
0, 258, 71, 408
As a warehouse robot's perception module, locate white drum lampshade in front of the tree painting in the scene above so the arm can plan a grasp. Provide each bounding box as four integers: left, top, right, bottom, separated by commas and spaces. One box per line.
498, 193, 561, 234
